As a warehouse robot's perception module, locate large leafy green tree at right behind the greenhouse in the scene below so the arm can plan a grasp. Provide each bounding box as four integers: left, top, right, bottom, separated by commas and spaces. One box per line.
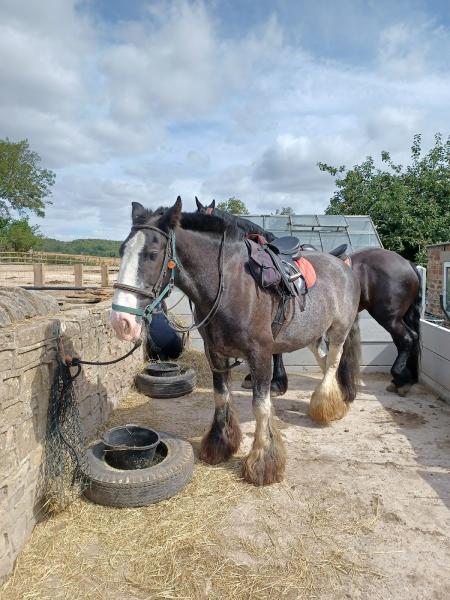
318, 134, 450, 264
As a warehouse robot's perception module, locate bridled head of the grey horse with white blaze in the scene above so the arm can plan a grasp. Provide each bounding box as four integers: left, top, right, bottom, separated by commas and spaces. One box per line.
111, 196, 181, 341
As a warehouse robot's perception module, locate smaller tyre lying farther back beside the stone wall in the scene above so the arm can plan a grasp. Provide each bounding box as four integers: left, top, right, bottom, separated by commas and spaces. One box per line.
135, 363, 197, 398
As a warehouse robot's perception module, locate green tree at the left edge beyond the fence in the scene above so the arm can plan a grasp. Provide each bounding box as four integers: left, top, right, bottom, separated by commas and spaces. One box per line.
0, 138, 55, 218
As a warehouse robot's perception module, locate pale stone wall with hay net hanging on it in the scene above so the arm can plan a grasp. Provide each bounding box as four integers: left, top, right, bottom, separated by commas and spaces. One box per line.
0, 290, 142, 579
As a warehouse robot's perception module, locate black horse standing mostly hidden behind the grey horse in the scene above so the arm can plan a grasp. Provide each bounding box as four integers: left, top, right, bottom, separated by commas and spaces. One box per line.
195, 198, 422, 396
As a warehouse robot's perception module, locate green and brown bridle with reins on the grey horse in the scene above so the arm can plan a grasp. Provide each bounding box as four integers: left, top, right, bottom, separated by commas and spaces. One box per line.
112, 225, 225, 333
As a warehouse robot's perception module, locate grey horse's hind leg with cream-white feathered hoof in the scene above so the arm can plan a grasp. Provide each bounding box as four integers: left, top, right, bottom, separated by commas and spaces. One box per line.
309, 342, 348, 423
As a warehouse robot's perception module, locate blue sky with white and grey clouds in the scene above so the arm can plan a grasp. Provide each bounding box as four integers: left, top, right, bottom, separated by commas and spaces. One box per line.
0, 0, 450, 239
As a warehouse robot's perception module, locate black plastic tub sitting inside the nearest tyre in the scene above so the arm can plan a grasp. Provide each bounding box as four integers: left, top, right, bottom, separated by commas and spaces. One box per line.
103, 425, 160, 470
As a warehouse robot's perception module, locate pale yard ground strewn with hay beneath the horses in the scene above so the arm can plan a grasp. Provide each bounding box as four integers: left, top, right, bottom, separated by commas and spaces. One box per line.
2, 374, 450, 600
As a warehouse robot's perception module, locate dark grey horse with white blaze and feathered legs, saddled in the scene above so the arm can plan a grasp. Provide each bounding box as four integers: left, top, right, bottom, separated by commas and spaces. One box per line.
111, 198, 360, 485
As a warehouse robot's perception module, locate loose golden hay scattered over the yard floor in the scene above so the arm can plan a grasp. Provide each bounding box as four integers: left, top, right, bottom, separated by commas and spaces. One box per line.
0, 384, 380, 600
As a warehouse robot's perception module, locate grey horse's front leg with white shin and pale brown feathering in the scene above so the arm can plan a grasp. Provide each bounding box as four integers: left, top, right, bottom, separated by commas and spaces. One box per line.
243, 354, 286, 485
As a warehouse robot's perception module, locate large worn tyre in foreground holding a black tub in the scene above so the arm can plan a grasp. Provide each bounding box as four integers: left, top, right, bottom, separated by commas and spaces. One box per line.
83, 432, 194, 507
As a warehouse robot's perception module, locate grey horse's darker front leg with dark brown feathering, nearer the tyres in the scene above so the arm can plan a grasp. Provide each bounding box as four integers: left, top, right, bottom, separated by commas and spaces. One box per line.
199, 354, 242, 465
